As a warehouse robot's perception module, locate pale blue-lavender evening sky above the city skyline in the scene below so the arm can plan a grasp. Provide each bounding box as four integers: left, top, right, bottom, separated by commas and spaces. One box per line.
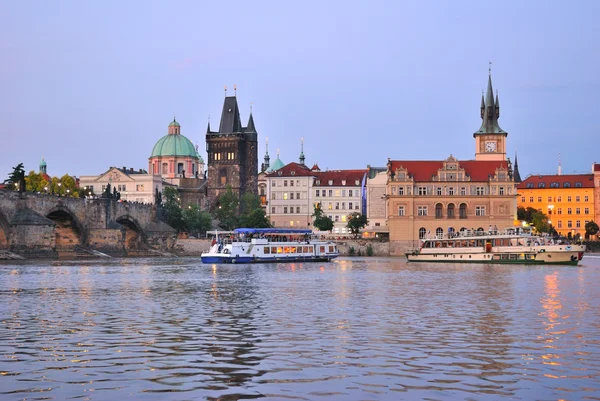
0, 0, 600, 178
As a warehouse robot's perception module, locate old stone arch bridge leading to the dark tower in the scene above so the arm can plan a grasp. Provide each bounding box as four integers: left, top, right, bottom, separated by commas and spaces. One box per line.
0, 190, 175, 257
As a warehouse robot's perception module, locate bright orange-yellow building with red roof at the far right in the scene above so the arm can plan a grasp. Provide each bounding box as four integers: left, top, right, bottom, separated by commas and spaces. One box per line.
517, 174, 595, 238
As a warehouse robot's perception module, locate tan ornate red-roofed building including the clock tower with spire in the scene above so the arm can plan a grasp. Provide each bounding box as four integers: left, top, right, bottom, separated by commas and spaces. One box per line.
386, 73, 516, 254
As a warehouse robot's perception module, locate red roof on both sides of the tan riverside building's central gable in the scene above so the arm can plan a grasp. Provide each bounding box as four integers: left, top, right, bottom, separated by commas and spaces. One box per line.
390, 160, 508, 182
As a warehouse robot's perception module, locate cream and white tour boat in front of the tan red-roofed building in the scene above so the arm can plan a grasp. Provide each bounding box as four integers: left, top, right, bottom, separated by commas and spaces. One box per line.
406, 228, 585, 265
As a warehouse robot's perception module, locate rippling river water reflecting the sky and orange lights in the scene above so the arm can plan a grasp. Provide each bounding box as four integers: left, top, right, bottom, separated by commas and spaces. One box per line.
0, 256, 600, 400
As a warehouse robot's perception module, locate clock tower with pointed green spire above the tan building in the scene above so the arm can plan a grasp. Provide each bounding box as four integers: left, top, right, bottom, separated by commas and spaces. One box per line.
473, 69, 508, 160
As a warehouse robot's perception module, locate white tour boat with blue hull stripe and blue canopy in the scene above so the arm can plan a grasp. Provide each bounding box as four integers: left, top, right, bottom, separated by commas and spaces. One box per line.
201, 228, 339, 263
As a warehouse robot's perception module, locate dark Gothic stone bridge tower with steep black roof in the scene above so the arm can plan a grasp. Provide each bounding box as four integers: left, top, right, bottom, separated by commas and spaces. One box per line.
206, 89, 258, 206
